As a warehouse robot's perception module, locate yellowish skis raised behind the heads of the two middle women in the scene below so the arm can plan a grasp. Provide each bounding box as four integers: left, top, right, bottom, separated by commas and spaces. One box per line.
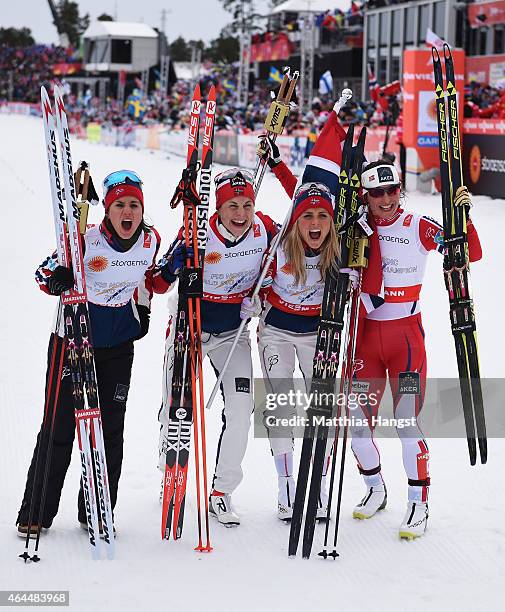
254, 67, 300, 195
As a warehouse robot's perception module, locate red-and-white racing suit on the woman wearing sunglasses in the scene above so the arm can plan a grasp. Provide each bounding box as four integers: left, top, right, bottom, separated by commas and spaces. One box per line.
351, 209, 482, 502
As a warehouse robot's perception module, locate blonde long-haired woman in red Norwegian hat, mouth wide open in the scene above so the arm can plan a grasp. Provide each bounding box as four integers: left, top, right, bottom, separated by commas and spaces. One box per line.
259, 183, 339, 520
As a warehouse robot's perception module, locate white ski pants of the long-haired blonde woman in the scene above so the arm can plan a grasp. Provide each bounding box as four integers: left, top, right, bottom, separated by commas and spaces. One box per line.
258, 322, 333, 466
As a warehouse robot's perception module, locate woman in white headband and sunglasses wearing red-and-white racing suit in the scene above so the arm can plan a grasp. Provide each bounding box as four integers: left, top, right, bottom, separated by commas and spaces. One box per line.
270, 133, 482, 538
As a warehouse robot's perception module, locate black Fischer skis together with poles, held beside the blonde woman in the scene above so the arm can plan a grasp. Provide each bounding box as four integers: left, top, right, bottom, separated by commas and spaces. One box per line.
288, 125, 366, 558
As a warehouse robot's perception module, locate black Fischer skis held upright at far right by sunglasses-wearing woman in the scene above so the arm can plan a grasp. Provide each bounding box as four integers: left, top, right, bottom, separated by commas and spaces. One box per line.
432, 44, 487, 465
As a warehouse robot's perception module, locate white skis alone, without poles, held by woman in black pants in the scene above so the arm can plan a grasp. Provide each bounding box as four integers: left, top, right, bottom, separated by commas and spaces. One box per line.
41, 87, 115, 559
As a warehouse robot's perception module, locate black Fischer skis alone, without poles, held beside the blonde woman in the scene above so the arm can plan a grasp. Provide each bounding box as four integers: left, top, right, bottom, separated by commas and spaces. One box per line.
288, 124, 366, 558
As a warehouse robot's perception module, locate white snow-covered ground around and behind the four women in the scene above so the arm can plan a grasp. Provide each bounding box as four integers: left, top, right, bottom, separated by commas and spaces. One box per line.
0, 115, 505, 612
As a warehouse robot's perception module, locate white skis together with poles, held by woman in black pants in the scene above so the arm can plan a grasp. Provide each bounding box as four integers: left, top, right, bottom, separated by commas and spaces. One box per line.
20, 87, 114, 561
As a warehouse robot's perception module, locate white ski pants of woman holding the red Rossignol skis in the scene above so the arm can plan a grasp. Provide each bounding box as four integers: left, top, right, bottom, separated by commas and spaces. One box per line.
158, 329, 254, 493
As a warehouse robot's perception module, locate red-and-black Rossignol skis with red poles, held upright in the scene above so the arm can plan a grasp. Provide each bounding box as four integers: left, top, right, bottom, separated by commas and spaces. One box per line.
161, 85, 216, 552
